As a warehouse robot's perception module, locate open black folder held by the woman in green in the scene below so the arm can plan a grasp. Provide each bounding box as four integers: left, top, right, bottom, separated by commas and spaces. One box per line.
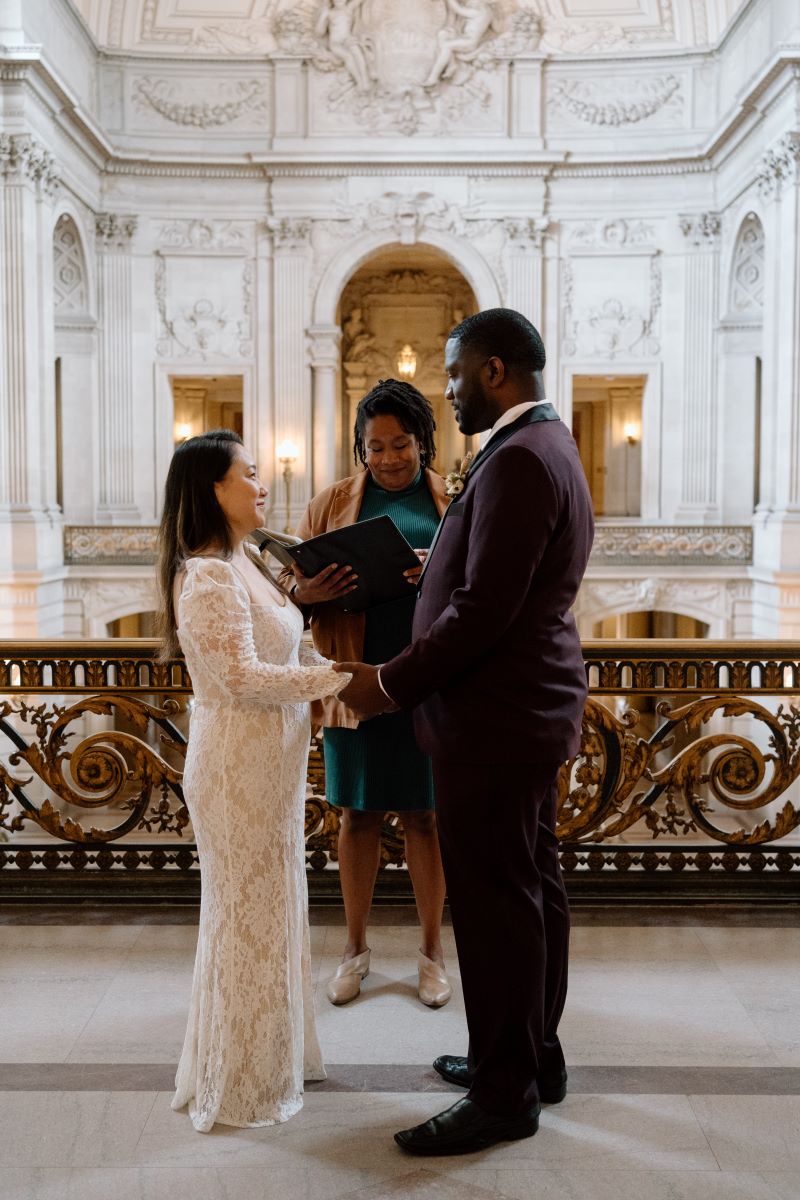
259, 516, 420, 612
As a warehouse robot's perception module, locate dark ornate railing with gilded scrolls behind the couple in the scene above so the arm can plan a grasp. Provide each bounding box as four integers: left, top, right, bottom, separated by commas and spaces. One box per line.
0, 640, 800, 898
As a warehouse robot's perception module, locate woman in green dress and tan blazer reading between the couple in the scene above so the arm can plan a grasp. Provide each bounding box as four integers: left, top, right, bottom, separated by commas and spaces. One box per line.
282, 379, 452, 1008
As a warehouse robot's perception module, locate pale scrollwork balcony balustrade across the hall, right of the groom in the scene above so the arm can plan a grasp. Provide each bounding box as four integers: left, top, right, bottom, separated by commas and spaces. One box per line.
591, 523, 753, 566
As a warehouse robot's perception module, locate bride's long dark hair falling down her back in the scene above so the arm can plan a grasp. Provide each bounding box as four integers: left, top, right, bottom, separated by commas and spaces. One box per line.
157, 430, 283, 660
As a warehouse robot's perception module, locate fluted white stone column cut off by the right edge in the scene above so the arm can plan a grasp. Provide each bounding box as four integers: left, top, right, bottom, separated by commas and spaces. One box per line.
753, 132, 800, 638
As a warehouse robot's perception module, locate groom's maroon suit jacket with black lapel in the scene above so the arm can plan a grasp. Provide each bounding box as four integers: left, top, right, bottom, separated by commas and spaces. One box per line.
380, 404, 594, 762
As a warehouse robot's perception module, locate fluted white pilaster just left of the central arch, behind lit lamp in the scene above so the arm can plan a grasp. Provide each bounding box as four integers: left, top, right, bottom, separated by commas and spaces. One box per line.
267, 218, 313, 527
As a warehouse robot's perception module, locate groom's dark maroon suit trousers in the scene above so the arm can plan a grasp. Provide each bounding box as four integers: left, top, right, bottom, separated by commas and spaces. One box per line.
433, 755, 570, 1115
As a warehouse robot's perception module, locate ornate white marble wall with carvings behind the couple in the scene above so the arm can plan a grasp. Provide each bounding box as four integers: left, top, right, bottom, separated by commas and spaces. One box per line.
0, 0, 800, 637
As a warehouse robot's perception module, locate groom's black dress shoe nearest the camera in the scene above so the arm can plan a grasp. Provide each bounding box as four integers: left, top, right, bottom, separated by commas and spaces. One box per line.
395, 1097, 540, 1154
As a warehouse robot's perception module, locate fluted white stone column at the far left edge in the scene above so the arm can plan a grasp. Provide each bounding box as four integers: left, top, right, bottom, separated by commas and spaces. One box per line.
0, 133, 62, 590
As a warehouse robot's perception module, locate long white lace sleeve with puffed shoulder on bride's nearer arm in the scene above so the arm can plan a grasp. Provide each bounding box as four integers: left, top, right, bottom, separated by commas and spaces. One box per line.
178, 559, 350, 704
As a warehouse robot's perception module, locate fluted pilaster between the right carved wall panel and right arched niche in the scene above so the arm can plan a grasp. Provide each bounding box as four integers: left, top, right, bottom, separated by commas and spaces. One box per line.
678, 212, 721, 522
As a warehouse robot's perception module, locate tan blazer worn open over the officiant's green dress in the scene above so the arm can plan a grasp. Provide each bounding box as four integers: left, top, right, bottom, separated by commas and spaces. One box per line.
279, 468, 450, 730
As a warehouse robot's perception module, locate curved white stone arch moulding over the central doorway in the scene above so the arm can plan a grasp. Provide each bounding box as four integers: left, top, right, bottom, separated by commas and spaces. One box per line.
313, 229, 503, 325
